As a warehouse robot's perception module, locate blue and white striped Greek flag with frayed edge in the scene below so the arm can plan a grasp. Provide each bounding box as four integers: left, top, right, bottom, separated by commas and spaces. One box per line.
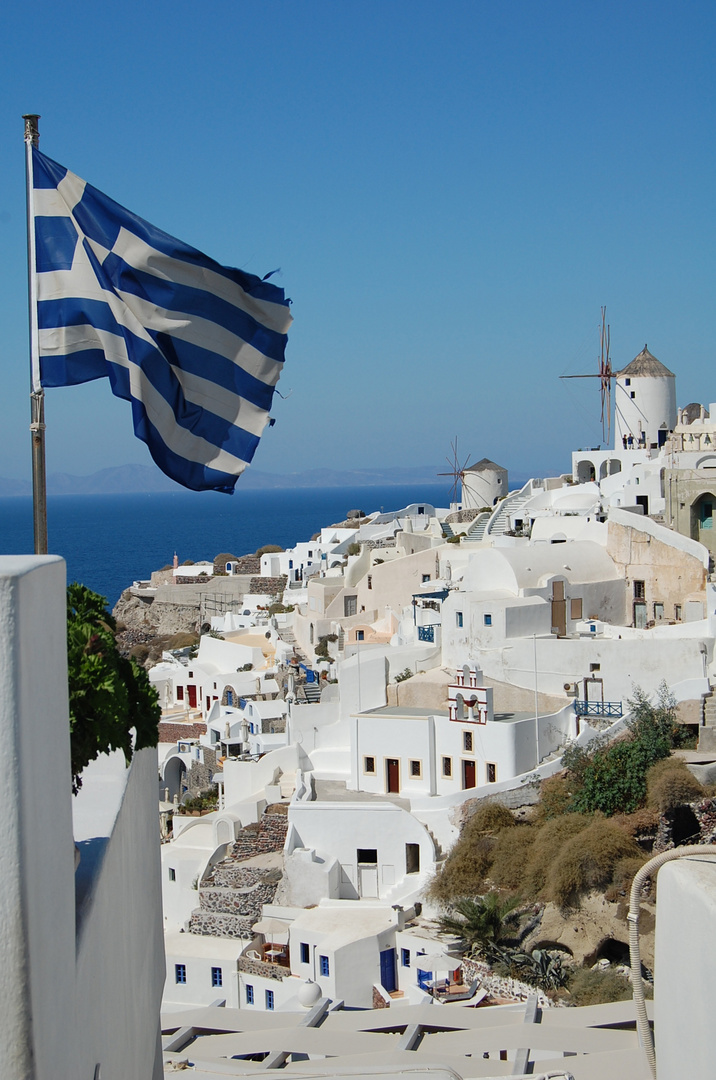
32, 148, 292, 494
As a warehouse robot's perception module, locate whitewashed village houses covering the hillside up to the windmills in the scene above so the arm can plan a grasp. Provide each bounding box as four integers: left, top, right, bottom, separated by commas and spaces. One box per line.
140, 347, 716, 1010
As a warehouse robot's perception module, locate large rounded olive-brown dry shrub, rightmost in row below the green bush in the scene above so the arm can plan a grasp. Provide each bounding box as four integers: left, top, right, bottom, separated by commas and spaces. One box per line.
545, 818, 639, 907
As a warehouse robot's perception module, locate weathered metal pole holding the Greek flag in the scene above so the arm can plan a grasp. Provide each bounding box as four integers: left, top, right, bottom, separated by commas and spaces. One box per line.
23, 112, 48, 555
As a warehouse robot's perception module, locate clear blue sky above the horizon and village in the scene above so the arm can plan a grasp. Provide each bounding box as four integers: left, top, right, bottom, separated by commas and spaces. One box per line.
0, 0, 716, 477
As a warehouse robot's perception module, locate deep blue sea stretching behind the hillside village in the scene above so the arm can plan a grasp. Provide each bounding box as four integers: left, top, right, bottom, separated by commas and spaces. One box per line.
0, 484, 449, 608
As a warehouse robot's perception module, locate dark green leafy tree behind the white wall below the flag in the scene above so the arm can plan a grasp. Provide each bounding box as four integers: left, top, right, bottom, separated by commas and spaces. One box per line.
67, 583, 162, 794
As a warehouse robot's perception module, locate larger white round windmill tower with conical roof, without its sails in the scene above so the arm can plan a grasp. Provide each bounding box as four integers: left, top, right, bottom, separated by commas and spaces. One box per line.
614, 346, 676, 450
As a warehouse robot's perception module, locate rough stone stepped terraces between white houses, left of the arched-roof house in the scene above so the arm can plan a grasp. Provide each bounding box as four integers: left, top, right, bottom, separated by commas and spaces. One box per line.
189, 807, 288, 937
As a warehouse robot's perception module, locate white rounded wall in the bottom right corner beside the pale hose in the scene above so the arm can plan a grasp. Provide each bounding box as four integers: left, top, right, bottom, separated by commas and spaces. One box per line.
653, 855, 716, 1080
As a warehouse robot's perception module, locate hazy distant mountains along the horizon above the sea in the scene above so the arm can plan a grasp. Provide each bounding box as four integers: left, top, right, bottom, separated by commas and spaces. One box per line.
0, 465, 455, 498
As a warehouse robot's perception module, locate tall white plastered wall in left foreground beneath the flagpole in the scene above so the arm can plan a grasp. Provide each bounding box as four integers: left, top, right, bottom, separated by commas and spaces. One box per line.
0, 556, 164, 1080
